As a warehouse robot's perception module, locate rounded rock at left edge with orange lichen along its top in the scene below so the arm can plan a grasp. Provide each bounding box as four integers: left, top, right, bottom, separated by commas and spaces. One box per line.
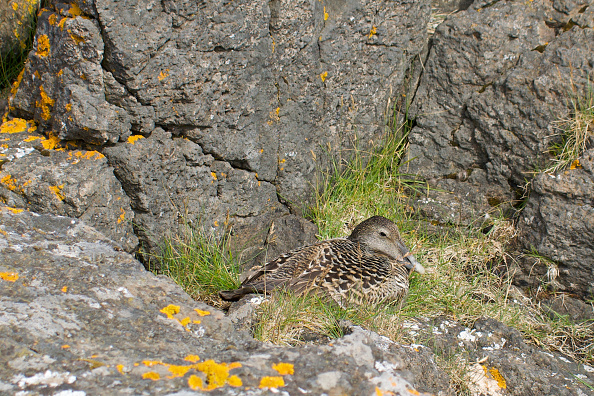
0, 119, 138, 251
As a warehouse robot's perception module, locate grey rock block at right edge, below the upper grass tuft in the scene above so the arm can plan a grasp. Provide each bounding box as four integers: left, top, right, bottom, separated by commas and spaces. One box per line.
518, 149, 594, 298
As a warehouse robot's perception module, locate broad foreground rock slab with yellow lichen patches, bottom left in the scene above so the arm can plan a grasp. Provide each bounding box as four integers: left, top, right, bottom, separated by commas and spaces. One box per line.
0, 208, 434, 395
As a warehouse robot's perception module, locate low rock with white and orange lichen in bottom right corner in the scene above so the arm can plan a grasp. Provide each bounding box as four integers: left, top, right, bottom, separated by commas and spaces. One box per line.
404, 318, 594, 396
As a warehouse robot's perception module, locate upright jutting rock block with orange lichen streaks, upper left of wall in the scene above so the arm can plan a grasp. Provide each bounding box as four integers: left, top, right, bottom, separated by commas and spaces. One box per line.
11, 4, 130, 144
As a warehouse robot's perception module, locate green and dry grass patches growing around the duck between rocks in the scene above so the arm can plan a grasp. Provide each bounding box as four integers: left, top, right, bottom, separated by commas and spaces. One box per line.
156, 111, 594, 393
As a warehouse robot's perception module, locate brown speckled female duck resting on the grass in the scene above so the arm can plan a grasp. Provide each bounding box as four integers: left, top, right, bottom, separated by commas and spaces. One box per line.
219, 216, 425, 307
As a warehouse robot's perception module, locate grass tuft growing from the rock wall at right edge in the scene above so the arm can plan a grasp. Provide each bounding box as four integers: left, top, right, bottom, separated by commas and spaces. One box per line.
544, 79, 594, 173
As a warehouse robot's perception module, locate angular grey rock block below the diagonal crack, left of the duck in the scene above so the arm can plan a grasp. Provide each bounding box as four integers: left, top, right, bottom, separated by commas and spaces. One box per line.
104, 128, 287, 251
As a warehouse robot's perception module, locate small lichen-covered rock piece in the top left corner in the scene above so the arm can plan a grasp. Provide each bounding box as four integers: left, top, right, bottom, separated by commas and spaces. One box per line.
0, 0, 39, 57
